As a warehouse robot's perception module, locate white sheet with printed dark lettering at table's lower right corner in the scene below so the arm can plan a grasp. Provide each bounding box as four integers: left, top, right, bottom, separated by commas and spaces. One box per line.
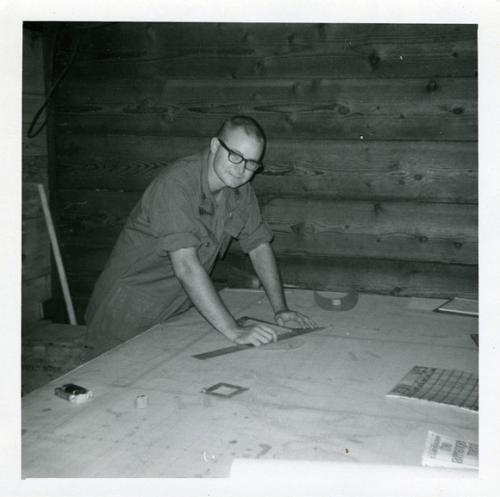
422, 431, 479, 469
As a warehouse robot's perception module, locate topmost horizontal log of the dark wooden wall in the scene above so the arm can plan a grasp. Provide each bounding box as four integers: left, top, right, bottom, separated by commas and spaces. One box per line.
59, 23, 477, 79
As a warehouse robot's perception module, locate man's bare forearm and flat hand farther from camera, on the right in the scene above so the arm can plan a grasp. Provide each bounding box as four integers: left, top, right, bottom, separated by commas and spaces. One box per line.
248, 242, 315, 328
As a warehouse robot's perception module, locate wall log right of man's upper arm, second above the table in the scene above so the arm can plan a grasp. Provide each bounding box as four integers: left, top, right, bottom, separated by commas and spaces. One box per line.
263, 198, 478, 264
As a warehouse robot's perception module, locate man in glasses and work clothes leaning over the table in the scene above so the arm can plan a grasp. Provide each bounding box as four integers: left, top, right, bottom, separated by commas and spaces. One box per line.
85, 116, 314, 353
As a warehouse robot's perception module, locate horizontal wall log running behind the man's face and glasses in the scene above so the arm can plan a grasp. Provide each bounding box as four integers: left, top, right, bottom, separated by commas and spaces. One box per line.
57, 134, 478, 203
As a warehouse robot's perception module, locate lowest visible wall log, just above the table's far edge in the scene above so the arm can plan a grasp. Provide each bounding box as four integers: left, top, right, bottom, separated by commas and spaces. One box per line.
68, 249, 478, 298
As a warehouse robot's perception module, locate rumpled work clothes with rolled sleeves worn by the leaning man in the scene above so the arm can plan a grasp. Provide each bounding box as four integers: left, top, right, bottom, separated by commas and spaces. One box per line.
85, 149, 272, 353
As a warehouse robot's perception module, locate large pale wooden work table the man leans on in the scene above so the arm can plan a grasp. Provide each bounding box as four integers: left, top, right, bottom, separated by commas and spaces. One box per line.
22, 290, 478, 478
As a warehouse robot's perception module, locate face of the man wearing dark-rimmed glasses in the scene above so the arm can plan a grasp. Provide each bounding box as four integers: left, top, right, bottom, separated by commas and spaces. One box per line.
212, 128, 264, 188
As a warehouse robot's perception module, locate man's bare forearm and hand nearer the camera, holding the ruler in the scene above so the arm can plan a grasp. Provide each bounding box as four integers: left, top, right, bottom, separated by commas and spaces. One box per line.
170, 247, 276, 346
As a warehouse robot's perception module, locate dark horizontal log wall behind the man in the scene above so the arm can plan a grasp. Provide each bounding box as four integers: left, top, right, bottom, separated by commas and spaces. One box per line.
44, 23, 478, 320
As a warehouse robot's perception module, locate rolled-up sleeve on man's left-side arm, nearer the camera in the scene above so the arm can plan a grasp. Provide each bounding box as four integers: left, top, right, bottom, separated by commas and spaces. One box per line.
145, 174, 201, 256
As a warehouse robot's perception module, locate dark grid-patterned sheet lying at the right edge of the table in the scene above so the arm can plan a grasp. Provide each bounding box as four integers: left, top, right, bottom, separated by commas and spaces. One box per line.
387, 366, 478, 411
